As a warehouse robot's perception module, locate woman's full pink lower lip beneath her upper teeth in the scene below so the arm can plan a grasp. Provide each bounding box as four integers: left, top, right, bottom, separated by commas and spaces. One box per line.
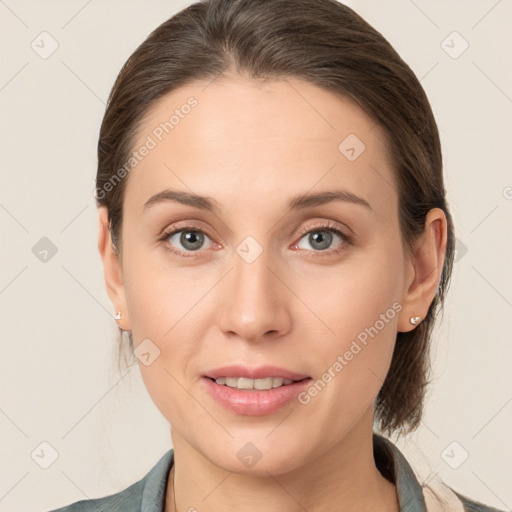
202, 377, 311, 416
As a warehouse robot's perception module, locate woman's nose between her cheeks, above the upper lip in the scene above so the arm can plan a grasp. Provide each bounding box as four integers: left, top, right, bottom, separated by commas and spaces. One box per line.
219, 244, 293, 343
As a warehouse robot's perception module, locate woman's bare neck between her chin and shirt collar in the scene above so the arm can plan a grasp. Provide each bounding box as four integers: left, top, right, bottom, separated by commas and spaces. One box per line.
166, 412, 399, 512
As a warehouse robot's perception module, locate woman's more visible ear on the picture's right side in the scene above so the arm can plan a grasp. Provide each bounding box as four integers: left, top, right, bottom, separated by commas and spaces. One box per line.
397, 208, 447, 332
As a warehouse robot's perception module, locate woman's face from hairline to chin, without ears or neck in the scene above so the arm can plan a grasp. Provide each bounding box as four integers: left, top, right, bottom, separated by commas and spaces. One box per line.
111, 77, 412, 474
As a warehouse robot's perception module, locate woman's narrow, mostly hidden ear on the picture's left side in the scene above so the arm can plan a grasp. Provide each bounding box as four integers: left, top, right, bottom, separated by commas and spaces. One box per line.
98, 206, 130, 331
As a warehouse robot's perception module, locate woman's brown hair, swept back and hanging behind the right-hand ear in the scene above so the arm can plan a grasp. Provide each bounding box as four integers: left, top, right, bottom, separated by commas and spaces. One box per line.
96, 0, 454, 435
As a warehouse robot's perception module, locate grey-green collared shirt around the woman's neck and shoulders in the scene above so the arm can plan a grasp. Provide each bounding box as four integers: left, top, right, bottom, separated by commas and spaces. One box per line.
50, 433, 500, 512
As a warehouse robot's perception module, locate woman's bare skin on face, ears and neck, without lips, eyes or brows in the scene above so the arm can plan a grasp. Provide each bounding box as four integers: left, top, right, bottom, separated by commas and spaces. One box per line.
98, 75, 446, 512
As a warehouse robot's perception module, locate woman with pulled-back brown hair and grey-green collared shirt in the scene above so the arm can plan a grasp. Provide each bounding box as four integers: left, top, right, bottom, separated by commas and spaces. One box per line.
48, 0, 504, 512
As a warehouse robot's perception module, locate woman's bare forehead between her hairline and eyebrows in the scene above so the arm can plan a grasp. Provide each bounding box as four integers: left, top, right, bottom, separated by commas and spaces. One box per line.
125, 76, 396, 217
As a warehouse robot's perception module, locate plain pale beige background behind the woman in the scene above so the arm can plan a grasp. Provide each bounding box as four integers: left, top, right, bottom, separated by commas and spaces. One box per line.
0, 0, 512, 512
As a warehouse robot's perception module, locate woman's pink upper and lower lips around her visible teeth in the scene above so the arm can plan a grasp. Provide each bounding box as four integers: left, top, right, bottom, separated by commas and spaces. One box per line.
201, 365, 311, 416
